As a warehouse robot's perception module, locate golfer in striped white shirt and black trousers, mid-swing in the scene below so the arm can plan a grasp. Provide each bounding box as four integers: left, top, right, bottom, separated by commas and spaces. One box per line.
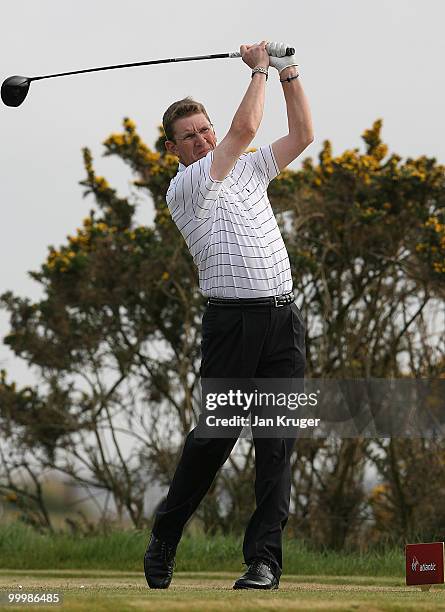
144, 41, 313, 589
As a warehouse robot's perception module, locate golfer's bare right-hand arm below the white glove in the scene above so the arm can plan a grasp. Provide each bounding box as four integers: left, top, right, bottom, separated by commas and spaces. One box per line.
272, 58, 314, 170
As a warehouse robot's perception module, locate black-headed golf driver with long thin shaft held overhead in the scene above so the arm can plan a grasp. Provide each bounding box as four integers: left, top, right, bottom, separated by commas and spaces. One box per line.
1, 46, 295, 106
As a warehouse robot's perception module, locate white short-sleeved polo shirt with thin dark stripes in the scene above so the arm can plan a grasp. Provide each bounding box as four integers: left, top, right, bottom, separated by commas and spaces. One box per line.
166, 145, 292, 298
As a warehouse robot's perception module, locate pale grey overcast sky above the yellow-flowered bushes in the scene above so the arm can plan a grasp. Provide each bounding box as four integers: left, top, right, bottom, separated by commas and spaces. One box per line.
0, 0, 445, 384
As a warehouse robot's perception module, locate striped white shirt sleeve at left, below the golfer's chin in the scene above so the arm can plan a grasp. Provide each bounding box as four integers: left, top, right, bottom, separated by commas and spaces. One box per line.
167, 151, 222, 219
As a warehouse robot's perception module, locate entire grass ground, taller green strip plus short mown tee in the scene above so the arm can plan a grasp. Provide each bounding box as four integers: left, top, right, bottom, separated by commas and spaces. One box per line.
0, 523, 445, 612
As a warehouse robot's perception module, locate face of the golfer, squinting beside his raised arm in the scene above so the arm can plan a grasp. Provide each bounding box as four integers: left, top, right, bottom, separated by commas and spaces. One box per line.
165, 113, 216, 166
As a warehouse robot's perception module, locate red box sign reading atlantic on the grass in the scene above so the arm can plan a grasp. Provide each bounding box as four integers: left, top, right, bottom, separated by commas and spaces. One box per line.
405, 542, 444, 586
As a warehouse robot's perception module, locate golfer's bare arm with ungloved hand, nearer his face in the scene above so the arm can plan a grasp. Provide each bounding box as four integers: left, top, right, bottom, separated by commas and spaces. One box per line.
210, 41, 269, 181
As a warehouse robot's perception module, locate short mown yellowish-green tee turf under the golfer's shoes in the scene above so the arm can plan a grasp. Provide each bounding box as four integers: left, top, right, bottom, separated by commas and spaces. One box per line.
0, 570, 445, 612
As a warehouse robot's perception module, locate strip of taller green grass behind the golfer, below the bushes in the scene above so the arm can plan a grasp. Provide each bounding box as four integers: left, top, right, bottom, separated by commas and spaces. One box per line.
0, 523, 405, 577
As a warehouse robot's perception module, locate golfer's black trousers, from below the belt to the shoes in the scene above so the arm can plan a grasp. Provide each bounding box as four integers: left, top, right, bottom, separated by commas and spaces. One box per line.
153, 303, 306, 577
